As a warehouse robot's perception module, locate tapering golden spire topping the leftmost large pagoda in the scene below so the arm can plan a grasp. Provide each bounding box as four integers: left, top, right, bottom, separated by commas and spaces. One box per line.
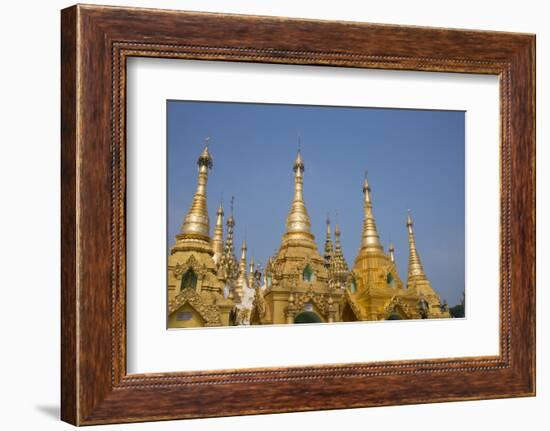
181, 138, 213, 242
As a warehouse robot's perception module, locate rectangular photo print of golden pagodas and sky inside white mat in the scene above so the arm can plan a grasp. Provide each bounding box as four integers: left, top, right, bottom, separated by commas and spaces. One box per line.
165, 100, 465, 329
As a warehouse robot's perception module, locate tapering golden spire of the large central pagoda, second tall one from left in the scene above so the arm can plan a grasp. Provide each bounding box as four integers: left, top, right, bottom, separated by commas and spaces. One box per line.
285, 150, 313, 240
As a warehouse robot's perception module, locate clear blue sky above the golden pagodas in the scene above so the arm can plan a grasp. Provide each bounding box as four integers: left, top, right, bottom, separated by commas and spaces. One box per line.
167, 101, 465, 306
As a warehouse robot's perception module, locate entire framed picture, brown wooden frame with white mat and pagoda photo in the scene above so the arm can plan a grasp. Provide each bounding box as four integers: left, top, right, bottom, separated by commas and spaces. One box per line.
61, 5, 535, 425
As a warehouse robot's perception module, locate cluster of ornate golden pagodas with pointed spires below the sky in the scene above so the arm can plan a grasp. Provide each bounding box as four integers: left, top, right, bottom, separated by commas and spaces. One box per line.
168, 140, 450, 328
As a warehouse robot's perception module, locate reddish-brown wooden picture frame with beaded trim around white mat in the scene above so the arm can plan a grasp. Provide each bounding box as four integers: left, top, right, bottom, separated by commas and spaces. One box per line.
61, 5, 535, 425
